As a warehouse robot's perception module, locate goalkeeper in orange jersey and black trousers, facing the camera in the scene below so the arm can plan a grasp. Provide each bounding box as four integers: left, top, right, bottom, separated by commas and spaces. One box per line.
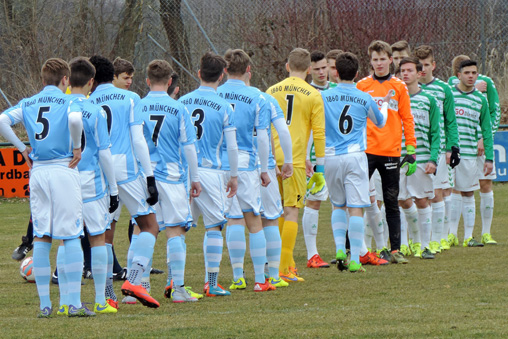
357, 40, 416, 263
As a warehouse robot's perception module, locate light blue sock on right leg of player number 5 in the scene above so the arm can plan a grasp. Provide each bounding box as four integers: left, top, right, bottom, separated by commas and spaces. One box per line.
64, 239, 83, 308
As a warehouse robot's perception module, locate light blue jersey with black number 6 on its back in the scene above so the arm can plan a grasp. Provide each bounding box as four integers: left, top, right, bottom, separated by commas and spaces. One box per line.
321, 83, 384, 156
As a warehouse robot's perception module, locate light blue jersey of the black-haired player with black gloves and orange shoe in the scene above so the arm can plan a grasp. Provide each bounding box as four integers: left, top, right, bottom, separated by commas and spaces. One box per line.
89, 84, 142, 184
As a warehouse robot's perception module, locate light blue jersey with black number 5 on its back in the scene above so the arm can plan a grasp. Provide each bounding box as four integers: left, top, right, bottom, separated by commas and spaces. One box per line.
5, 86, 81, 161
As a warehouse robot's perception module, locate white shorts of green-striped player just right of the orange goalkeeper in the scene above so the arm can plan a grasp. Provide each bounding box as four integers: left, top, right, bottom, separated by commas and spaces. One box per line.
399, 164, 434, 200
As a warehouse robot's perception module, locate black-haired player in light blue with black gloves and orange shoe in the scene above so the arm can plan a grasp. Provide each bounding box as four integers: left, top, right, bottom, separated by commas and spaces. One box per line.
90, 56, 159, 308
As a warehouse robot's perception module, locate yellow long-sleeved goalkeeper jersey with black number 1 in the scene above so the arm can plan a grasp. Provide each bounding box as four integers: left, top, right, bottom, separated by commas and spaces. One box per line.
266, 77, 325, 168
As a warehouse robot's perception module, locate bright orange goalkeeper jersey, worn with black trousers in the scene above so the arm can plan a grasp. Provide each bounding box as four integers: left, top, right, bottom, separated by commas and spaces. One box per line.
356, 75, 416, 157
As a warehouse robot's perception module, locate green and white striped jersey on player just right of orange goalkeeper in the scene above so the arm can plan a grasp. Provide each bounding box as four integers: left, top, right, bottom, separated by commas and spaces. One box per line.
401, 89, 442, 164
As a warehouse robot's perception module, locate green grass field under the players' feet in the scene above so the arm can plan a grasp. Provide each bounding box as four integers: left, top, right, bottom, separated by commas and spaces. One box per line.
0, 184, 508, 338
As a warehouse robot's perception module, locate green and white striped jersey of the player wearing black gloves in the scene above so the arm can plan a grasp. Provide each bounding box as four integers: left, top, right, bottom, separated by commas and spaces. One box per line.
420, 78, 459, 152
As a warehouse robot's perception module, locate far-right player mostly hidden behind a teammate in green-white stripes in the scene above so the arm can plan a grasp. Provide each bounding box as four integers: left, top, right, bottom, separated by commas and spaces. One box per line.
448, 55, 501, 245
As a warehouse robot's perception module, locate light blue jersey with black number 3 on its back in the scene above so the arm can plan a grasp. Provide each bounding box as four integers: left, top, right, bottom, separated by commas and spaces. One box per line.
179, 86, 235, 169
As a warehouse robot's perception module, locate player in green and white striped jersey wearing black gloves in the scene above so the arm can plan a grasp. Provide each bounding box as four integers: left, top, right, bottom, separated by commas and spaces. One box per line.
414, 45, 460, 253
